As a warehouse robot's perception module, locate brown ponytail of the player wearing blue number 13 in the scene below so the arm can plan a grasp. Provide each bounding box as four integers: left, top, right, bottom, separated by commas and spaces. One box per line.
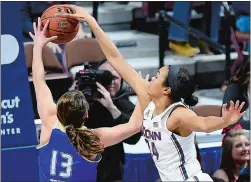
65, 124, 104, 159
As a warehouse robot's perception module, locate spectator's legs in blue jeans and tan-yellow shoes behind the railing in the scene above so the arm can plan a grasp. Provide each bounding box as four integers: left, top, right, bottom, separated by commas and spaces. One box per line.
168, 1, 221, 57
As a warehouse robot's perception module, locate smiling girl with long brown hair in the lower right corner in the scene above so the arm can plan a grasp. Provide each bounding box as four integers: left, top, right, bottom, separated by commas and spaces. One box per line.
213, 125, 250, 182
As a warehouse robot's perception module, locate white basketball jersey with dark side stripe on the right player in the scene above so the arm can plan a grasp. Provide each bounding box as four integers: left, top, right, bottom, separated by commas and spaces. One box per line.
143, 102, 202, 181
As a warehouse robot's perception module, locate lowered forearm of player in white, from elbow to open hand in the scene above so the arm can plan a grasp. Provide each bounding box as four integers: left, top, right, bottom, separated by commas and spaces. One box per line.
203, 116, 228, 132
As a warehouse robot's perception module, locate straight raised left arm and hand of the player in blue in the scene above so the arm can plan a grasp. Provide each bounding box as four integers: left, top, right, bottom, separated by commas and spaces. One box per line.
29, 18, 57, 144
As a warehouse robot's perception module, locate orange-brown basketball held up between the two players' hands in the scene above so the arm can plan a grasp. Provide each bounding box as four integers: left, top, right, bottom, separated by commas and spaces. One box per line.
41, 5, 79, 44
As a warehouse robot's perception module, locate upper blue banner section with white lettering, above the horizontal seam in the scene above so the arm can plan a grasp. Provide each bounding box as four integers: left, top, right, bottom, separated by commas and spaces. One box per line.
1, 2, 37, 148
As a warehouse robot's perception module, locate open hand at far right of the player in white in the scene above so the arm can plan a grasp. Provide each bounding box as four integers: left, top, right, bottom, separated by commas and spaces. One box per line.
222, 100, 245, 125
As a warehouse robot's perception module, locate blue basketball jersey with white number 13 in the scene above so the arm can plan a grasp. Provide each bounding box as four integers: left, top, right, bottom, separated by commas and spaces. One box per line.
38, 128, 100, 182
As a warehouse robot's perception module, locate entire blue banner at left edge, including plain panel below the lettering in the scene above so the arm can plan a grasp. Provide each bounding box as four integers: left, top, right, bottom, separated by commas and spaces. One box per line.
1, 1, 39, 181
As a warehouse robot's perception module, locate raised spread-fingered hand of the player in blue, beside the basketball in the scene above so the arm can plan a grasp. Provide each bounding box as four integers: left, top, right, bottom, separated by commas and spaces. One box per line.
29, 17, 57, 47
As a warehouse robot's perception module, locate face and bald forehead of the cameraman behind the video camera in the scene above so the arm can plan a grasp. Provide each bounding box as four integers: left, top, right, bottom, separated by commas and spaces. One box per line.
99, 63, 121, 97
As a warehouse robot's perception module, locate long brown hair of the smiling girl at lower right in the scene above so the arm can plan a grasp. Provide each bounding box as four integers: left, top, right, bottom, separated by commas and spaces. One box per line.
220, 129, 249, 182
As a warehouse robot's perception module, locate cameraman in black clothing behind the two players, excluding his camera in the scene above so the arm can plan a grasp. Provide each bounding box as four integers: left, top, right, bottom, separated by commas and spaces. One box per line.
85, 61, 141, 182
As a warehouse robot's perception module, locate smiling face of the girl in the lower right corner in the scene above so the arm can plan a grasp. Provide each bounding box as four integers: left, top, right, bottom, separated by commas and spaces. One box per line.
232, 135, 250, 162
